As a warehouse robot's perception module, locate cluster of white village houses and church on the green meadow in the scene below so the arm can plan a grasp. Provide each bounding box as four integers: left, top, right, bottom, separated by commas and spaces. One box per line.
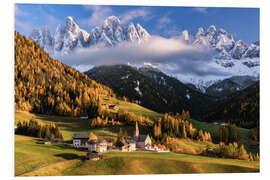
72, 123, 169, 160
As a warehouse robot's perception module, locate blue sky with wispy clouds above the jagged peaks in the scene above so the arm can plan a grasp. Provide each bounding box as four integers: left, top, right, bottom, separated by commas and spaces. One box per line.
15, 4, 259, 43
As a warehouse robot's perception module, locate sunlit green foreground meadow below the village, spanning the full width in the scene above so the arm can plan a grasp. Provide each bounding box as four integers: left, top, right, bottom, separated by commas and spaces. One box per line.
15, 135, 259, 176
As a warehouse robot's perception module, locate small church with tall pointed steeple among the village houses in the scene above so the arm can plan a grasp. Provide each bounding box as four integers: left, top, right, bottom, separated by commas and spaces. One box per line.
133, 122, 152, 149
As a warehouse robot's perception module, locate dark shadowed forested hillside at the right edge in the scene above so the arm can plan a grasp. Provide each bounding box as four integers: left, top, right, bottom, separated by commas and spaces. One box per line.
200, 82, 260, 128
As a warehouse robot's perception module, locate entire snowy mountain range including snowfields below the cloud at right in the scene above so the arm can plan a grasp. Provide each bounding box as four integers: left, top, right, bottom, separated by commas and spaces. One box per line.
30, 16, 260, 93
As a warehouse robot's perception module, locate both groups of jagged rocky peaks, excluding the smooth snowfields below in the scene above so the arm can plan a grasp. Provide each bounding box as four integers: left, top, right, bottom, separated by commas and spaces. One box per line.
30, 16, 260, 60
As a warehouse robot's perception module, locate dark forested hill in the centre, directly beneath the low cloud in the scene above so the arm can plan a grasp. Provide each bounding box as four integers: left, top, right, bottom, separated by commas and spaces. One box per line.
85, 65, 213, 116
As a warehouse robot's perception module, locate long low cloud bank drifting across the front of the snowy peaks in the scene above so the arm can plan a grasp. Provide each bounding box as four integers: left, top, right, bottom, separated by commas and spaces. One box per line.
61, 36, 228, 76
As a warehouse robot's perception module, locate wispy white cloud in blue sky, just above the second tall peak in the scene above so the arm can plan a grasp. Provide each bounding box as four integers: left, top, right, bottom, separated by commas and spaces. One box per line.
120, 8, 151, 24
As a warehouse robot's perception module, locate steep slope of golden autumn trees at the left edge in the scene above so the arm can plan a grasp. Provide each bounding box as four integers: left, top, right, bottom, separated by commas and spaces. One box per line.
14, 32, 114, 116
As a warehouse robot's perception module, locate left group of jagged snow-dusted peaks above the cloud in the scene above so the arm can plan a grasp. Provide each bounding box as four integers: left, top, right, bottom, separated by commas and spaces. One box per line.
30, 16, 151, 56
